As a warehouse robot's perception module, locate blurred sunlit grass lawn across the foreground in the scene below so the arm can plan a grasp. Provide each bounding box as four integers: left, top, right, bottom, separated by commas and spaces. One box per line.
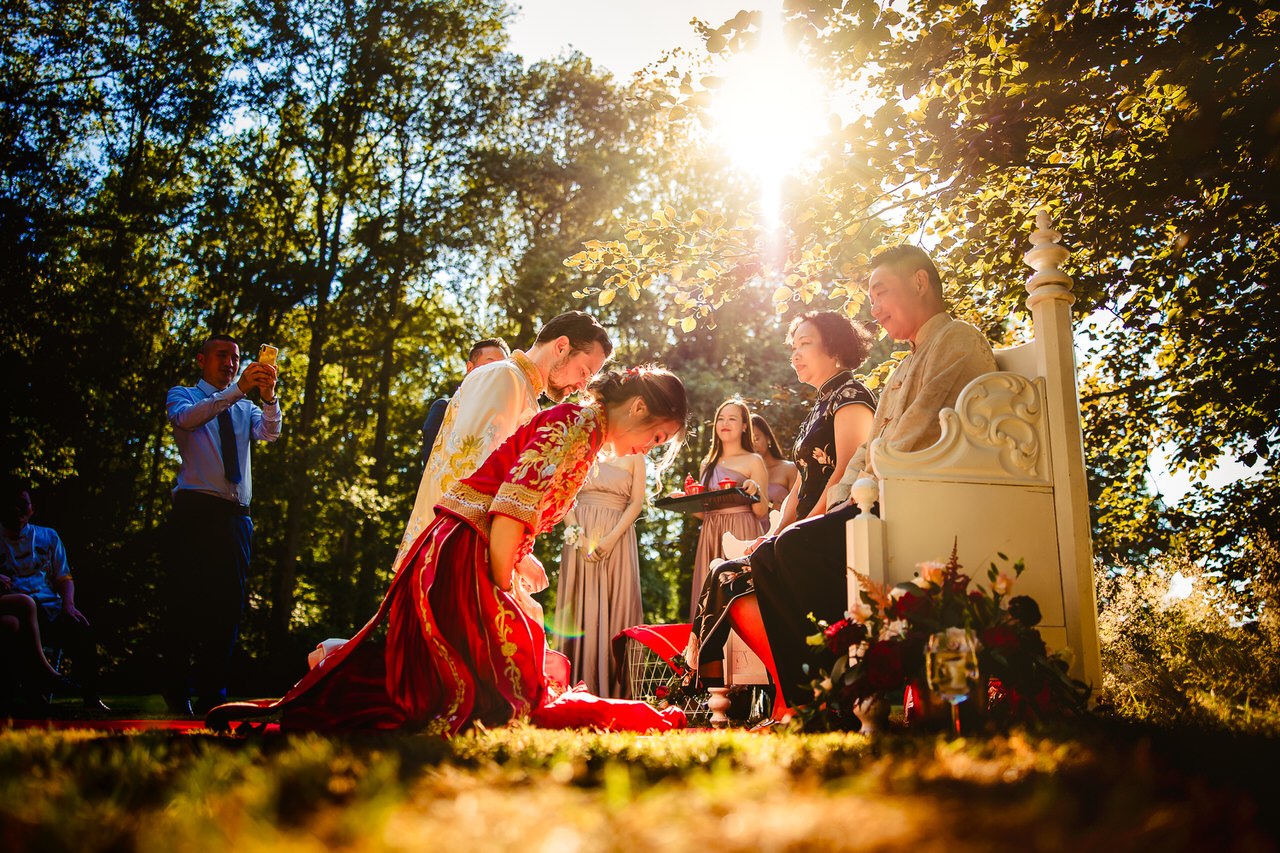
0, 691, 1280, 853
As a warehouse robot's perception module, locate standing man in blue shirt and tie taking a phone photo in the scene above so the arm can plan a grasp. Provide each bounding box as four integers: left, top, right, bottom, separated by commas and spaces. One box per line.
165, 334, 280, 713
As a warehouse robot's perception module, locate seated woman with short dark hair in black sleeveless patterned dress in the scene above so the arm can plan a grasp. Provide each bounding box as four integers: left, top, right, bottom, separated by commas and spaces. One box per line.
687, 311, 876, 710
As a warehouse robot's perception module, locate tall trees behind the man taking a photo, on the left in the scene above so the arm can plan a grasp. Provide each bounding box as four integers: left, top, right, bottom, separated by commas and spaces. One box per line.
0, 0, 747, 694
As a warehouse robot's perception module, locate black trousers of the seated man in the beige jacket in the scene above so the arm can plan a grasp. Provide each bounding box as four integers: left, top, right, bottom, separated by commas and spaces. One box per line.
750, 505, 858, 707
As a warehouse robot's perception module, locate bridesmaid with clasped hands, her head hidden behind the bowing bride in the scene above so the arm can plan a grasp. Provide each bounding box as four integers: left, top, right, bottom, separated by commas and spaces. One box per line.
554, 455, 645, 698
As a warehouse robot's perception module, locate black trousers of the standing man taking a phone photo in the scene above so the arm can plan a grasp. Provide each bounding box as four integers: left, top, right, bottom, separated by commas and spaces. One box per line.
165, 492, 253, 704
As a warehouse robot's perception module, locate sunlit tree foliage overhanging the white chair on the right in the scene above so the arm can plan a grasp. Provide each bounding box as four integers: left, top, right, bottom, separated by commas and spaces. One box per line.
581, 0, 1280, 591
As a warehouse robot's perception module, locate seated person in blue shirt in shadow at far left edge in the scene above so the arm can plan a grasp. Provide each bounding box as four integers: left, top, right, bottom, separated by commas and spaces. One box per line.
0, 473, 106, 710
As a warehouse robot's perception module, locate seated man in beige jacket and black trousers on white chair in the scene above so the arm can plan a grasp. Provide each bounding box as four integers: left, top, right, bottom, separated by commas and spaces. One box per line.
696, 246, 996, 719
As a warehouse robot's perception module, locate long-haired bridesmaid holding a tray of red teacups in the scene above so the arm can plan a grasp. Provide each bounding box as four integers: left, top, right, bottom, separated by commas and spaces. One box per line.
690, 400, 769, 619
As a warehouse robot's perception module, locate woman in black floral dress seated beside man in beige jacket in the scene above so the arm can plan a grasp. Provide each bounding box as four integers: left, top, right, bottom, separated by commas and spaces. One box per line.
690, 311, 876, 720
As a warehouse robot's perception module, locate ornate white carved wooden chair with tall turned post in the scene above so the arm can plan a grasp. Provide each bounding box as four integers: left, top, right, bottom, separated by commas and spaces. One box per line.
846, 211, 1102, 689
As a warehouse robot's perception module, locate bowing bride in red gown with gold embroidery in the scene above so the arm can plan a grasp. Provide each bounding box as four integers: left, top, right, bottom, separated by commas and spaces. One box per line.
206, 368, 687, 735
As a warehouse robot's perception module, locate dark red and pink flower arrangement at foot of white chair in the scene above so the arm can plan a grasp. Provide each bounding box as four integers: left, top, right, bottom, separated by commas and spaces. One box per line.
806, 540, 1089, 721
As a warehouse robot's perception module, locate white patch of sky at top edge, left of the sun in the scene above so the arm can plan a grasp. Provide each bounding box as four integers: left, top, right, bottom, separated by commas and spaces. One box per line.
508, 0, 760, 78
